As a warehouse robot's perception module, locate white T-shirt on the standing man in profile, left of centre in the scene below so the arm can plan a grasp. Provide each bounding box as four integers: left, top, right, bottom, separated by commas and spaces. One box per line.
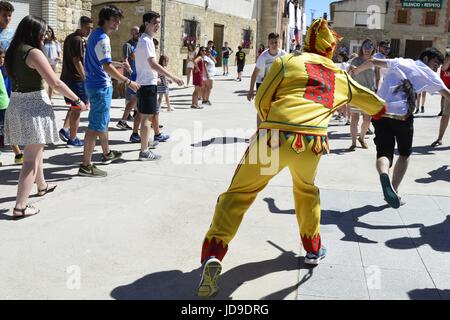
134, 33, 158, 86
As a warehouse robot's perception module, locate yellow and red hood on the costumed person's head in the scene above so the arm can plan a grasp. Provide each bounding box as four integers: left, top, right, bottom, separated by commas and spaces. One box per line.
303, 18, 342, 59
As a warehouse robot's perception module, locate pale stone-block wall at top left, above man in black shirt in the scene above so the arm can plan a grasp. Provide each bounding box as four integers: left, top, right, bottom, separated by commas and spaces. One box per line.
56, 0, 92, 42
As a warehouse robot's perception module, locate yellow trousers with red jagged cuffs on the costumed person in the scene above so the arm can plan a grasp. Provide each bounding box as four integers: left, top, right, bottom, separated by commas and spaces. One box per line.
201, 130, 329, 262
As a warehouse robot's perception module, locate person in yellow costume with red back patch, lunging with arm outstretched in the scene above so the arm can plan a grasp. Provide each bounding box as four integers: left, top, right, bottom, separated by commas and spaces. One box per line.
197, 19, 385, 297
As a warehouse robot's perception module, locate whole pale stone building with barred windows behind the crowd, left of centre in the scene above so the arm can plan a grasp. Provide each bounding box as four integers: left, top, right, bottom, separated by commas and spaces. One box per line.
92, 0, 257, 75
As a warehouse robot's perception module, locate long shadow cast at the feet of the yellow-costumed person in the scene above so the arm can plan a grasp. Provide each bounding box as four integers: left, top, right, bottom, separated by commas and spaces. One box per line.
111, 245, 313, 300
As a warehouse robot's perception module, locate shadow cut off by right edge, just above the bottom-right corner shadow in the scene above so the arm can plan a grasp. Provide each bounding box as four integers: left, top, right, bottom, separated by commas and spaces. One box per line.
386, 216, 450, 252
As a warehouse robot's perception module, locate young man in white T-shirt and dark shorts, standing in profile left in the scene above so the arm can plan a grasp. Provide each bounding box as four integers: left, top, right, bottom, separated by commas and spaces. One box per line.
135, 11, 184, 161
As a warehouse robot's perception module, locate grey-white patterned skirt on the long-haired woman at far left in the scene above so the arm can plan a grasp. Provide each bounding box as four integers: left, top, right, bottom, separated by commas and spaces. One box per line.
5, 90, 59, 145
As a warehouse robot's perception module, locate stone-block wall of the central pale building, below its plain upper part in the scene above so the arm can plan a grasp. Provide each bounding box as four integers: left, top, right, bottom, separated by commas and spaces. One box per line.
92, 0, 256, 76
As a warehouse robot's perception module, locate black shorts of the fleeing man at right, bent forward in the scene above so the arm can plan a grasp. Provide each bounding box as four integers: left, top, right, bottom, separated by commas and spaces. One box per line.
372, 116, 414, 166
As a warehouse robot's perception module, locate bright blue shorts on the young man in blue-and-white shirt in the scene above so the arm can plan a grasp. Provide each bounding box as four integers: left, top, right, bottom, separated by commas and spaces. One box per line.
87, 86, 113, 132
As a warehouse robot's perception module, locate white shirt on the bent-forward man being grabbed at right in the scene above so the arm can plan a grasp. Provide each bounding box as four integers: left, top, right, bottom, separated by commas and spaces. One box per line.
378, 58, 446, 116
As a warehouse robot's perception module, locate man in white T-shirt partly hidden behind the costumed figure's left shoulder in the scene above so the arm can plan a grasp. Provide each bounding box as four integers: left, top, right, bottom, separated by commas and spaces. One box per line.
247, 32, 287, 127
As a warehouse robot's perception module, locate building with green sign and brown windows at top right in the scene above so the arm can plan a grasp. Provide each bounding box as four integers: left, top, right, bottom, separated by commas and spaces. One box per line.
330, 0, 450, 59
